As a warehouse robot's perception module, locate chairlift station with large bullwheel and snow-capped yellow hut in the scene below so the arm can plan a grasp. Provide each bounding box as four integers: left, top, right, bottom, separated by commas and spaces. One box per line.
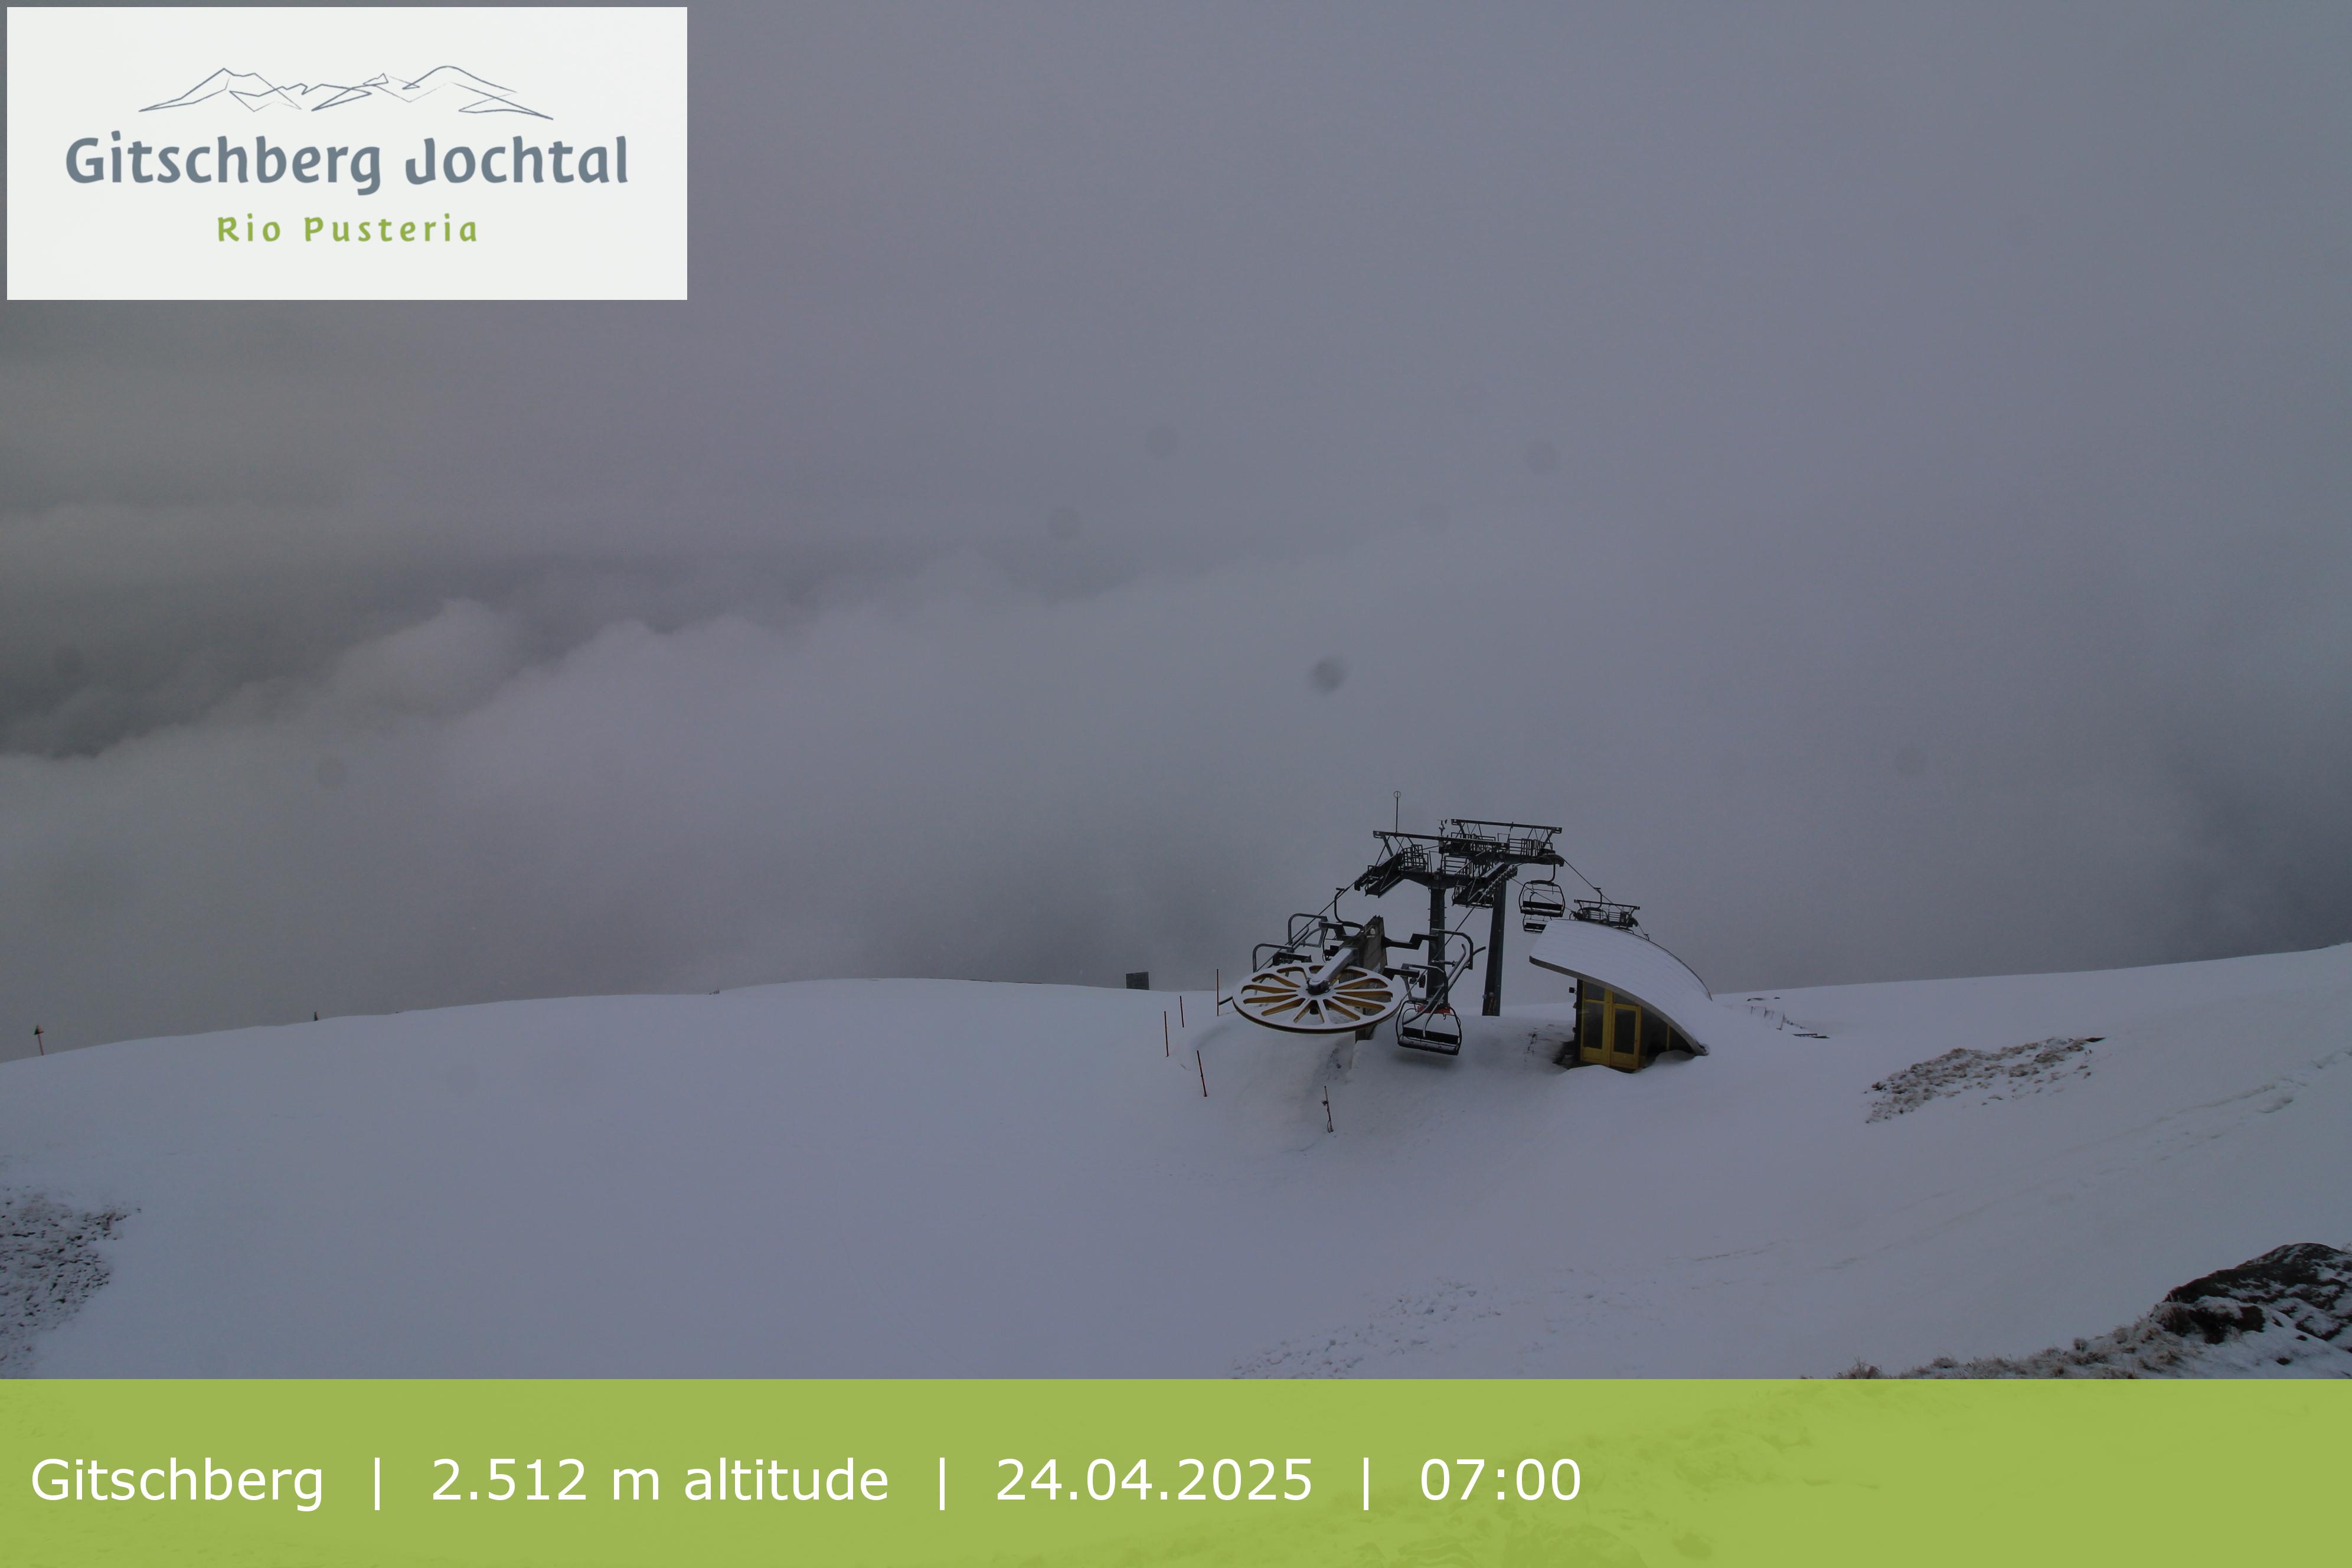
1233, 818, 1705, 1072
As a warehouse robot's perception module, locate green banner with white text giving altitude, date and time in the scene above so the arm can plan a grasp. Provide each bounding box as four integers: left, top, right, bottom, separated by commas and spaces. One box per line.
0, 1380, 2352, 1568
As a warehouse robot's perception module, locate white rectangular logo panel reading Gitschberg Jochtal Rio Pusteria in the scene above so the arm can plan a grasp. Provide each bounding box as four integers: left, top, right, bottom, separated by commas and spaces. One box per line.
7, 7, 687, 299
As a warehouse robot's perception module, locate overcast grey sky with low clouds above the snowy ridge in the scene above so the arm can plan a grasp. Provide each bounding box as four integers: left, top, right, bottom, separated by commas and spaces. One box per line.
0, 5, 2352, 1053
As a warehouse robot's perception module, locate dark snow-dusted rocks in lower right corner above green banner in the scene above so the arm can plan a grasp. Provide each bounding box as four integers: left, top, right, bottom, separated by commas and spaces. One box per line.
1844, 1242, 2352, 1377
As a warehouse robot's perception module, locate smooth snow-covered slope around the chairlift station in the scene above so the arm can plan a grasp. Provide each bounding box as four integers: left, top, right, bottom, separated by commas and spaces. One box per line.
0, 948, 2352, 1375
